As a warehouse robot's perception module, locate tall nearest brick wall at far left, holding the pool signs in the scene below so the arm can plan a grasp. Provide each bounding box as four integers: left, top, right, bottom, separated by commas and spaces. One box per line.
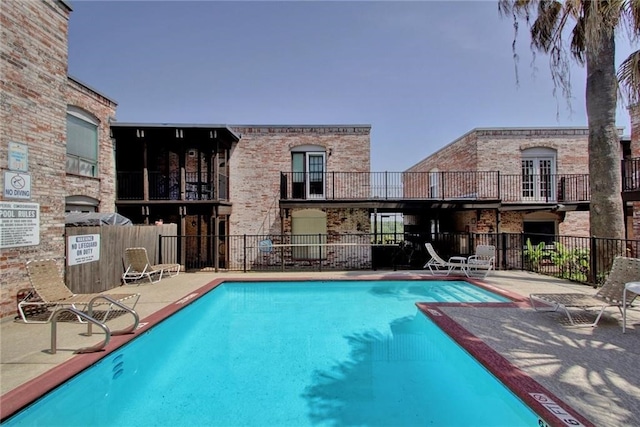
0, 0, 69, 316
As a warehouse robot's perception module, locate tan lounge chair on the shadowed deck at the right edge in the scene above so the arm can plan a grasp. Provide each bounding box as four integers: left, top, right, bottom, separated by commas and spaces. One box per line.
529, 257, 640, 327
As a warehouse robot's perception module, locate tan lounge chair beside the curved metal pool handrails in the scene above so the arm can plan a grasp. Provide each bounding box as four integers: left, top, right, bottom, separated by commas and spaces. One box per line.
18, 259, 140, 323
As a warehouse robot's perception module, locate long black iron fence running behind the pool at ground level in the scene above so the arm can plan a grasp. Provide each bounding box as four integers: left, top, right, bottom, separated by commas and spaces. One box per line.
160, 233, 640, 284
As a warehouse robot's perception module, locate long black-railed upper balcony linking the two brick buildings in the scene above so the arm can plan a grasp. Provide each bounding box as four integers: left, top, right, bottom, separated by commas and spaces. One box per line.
280, 171, 590, 204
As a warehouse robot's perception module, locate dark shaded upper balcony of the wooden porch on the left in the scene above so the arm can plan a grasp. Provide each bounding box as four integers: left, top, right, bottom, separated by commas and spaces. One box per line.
116, 171, 228, 201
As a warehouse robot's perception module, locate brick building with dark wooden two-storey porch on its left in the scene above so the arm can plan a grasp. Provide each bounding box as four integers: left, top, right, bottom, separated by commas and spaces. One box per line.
111, 122, 370, 268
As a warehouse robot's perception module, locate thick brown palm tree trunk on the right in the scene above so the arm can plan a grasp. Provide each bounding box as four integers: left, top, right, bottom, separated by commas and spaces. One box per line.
586, 31, 625, 239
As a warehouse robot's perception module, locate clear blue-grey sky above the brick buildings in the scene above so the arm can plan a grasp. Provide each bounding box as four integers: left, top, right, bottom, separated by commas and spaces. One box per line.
68, 0, 638, 172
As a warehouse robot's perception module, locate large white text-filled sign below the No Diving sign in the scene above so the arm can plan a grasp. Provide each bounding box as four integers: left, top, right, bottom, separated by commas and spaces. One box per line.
0, 202, 40, 248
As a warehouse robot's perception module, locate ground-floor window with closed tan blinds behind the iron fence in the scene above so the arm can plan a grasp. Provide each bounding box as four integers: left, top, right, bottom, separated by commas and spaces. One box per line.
291, 209, 327, 260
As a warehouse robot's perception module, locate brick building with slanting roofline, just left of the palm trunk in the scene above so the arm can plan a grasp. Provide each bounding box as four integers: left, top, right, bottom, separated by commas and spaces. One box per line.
406, 125, 637, 242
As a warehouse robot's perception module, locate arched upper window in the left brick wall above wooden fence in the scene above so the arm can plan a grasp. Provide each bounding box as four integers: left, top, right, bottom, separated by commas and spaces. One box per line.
67, 107, 98, 177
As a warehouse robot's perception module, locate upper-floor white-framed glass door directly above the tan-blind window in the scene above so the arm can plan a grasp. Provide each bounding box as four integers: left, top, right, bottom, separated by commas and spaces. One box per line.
291, 146, 326, 199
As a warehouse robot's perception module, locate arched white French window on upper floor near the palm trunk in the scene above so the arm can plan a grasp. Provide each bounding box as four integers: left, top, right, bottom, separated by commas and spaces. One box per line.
521, 148, 556, 202
